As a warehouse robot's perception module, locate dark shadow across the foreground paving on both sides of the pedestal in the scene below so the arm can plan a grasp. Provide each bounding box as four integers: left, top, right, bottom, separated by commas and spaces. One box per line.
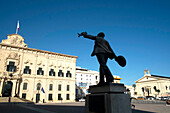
0, 104, 158, 113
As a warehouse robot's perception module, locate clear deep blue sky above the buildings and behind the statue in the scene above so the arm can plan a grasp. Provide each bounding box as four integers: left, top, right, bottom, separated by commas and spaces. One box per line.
0, 0, 170, 85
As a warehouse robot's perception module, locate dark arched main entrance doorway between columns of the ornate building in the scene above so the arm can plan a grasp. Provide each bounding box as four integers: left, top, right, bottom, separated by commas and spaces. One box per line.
2, 81, 13, 97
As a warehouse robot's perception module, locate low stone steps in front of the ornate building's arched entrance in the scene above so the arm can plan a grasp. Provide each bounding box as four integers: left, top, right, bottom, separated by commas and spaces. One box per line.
0, 97, 34, 104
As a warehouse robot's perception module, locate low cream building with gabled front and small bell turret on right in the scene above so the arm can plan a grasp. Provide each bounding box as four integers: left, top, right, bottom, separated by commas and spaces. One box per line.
135, 70, 170, 97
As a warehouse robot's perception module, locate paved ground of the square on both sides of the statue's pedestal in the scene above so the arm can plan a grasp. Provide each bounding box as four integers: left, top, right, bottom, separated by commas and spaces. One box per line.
0, 102, 170, 113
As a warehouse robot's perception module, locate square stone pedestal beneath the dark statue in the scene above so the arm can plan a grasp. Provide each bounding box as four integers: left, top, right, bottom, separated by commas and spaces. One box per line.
86, 83, 132, 113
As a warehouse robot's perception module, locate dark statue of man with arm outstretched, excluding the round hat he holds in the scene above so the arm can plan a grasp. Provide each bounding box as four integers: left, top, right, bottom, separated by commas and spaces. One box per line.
78, 32, 117, 84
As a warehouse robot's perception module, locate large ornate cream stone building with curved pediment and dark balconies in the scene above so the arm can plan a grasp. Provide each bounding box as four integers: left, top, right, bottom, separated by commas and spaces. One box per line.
0, 34, 77, 102
